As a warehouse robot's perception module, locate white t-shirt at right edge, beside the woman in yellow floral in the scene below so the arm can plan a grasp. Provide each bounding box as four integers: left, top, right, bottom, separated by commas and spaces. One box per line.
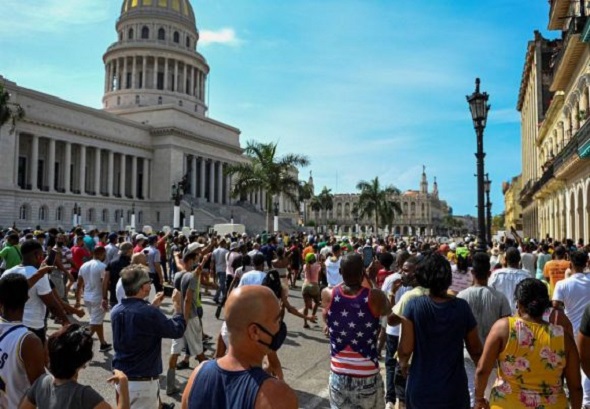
553, 273, 590, 334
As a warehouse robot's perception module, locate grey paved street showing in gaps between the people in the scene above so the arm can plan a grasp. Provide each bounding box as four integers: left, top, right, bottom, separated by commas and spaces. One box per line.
50, 290, 340, 408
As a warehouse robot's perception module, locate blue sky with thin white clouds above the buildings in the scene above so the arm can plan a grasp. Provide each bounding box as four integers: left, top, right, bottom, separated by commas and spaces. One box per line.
0, 0, 558, 214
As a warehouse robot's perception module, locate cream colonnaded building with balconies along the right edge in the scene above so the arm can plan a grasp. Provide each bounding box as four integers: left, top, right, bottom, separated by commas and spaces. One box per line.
519, 0, 590, 242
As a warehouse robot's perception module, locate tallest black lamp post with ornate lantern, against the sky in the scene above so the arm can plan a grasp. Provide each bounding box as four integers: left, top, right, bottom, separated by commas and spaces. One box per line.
466, 78, 490, 251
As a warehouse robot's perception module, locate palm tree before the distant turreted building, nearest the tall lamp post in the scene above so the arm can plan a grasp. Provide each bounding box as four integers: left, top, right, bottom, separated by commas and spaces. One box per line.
356, 176, 402, 233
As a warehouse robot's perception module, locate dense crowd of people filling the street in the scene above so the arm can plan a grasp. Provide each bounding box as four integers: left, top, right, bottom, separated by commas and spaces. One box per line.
0, 227, 590, 409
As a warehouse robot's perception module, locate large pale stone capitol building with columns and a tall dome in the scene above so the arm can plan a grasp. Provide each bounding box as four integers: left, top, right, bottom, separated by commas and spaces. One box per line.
0, 0, 298, 230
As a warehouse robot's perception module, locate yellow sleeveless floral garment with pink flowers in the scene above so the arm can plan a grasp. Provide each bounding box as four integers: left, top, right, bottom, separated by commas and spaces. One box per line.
490, 317, 569, 409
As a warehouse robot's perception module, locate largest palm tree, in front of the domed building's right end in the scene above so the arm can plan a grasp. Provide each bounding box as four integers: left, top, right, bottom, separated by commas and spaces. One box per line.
225, 141, 309, 231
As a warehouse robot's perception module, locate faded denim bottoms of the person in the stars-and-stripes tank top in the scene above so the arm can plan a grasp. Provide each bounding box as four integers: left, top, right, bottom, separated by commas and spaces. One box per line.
329, 372, 385, 409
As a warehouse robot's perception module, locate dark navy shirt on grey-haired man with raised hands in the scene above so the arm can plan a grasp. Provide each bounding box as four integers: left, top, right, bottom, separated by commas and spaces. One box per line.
111, 298, 186, 379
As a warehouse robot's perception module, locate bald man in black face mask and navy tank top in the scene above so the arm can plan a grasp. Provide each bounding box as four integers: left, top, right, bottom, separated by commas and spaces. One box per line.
182, 286, 298, 409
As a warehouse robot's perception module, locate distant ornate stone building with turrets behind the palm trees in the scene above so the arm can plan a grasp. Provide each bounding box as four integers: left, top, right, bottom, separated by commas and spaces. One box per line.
305, 170, 450, 236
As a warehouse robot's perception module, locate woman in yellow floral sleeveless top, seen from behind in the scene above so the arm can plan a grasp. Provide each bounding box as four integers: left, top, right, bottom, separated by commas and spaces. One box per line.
474, 278, 582, 409
